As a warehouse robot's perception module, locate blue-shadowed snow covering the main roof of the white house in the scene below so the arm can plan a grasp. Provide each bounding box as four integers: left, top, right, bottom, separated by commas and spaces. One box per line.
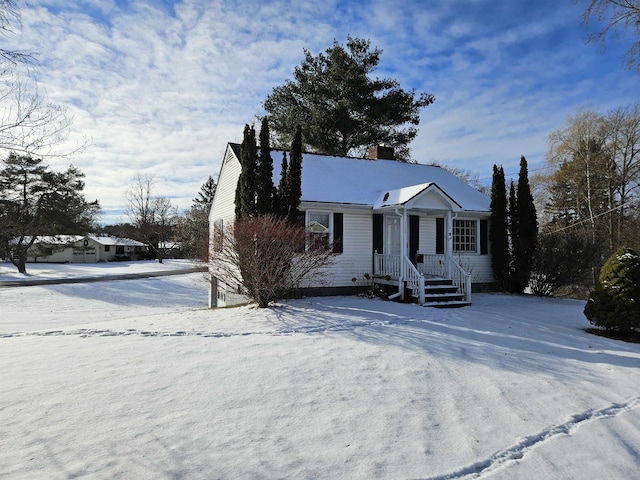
260, 147, 491, 212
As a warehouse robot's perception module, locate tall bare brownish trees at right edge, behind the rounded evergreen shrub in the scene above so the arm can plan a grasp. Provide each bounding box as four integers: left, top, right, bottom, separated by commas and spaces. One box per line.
545, 104, 640, 256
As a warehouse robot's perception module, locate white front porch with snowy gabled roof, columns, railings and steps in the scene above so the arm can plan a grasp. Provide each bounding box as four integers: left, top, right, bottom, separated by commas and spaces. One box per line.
373, 183, 471, 307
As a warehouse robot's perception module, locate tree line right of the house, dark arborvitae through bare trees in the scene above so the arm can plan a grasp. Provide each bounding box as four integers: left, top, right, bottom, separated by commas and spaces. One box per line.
490, 103, 640, 295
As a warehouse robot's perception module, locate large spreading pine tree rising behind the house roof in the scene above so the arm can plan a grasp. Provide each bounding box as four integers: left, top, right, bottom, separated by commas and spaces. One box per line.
264, 37, 434, 161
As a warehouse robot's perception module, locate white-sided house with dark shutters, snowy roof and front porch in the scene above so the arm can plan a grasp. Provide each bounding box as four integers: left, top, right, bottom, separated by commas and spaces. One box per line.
209, 143, 495, 306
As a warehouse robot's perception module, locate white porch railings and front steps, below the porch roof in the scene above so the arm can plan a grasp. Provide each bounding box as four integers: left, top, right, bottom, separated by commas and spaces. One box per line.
373, 252, 471, 308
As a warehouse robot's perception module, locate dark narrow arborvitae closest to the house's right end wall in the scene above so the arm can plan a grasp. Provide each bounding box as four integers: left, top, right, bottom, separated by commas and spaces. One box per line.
489, 165, 511, 291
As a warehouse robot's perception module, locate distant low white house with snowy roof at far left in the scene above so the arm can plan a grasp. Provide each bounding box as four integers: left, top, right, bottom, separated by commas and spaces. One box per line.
14, 235, 148, 263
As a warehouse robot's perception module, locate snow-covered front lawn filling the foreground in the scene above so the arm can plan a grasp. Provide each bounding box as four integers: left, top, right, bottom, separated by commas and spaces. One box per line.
0, 265, 640, 479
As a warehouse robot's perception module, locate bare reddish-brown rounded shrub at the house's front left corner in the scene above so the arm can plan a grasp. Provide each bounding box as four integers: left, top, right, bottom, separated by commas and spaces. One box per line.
209, 215, 331, 308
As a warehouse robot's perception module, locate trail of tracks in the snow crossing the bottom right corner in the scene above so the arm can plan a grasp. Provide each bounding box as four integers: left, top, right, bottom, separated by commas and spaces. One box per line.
425, 396, 640, 480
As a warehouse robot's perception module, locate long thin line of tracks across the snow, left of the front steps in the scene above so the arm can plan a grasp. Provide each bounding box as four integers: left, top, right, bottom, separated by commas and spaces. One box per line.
0, 321, 389, 338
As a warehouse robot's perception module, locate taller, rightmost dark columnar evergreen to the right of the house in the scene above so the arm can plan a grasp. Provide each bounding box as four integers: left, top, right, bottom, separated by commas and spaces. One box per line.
512, 156, 538, 293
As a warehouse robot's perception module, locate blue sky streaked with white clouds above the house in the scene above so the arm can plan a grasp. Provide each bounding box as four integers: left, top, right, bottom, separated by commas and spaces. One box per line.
2, 0, 640, 224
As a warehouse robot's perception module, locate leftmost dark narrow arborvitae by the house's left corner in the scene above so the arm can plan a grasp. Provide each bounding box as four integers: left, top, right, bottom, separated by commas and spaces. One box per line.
235, 125, 258, 220
